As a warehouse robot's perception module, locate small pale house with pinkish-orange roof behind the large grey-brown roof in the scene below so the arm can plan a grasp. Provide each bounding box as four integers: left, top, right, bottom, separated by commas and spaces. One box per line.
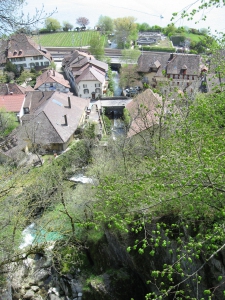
34, 70, 70, 93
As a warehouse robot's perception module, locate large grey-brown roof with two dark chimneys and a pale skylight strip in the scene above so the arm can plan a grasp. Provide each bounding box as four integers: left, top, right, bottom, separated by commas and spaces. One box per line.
20, 92, 90, 144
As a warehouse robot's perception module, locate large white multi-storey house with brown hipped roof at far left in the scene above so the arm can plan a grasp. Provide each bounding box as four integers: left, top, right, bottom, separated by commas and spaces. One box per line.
0, 34, 53, 69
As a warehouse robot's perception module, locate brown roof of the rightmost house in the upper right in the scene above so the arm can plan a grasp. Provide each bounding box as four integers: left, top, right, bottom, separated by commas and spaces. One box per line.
167, 53, 201, 75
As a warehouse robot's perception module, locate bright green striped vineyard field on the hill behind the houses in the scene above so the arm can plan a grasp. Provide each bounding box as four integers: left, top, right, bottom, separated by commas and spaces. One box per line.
33, 31, 105, 47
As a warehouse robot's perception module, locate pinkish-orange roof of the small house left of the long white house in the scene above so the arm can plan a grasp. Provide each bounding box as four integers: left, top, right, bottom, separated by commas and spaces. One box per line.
34, 70, 70, 89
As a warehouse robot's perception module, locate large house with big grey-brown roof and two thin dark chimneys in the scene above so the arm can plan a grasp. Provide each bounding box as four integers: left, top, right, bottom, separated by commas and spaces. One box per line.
20, 91, 90, 151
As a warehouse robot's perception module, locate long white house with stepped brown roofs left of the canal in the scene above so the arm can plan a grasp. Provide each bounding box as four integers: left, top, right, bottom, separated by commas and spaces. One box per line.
62, 50, 108, 99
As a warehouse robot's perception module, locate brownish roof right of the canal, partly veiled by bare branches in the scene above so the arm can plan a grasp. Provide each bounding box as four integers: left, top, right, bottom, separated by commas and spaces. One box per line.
126, 89, 162, 137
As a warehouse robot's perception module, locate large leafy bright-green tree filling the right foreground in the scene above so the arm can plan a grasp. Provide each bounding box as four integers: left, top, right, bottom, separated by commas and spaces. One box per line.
85, 86, 225, 300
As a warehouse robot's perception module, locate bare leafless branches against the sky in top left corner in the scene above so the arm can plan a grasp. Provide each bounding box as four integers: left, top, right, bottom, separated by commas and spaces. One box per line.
0, 0, 55, 36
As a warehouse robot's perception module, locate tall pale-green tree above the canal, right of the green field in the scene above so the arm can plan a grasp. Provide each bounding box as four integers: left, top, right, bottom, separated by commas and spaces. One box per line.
114, 17, 137, 47
